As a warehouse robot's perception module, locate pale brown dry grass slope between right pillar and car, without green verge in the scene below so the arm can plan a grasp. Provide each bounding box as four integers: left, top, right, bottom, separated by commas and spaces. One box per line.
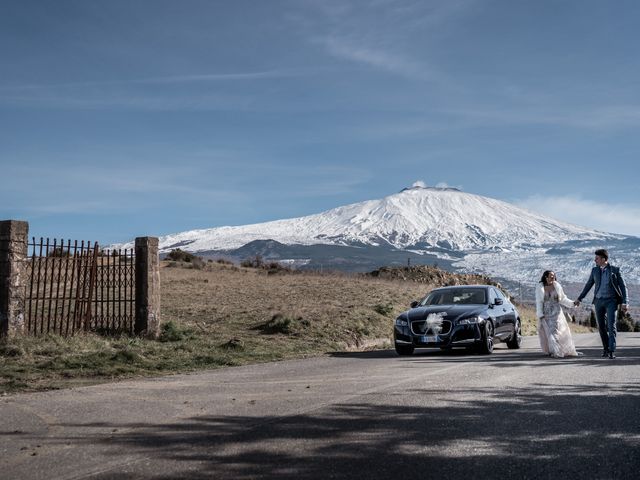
162, 264, 430, 352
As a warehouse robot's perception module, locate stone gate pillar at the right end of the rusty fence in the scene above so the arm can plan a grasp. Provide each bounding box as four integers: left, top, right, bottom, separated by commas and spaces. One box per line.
133, 237, 160, 338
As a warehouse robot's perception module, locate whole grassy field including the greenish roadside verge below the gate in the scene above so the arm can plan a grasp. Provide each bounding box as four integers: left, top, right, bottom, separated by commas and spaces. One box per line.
0, 262, 592, 393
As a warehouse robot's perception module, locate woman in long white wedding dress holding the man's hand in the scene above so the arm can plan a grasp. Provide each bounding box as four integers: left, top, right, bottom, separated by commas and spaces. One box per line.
536, 270, 578, 358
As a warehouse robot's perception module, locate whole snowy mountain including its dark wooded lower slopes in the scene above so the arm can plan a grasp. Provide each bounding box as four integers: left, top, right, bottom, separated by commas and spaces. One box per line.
117, 186, 640, 284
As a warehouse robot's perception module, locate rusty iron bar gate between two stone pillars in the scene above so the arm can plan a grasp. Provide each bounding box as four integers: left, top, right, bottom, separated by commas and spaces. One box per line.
25, 237, 135, 336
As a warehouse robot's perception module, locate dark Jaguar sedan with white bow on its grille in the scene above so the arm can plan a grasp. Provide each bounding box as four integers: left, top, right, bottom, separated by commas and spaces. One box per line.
393, 285, 522, 355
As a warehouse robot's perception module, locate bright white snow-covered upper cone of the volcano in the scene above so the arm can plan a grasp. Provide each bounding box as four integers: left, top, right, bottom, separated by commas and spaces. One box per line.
151, 186, 621, 252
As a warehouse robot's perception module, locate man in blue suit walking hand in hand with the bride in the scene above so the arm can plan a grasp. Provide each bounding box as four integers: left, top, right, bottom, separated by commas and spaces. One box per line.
574, 248, 627, 359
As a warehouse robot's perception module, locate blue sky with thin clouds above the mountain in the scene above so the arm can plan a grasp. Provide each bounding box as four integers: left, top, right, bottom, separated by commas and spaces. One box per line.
0, 0, 640, 243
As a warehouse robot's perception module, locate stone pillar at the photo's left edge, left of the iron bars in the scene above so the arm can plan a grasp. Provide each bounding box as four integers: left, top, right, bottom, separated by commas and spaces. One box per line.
0, 220, 29, 337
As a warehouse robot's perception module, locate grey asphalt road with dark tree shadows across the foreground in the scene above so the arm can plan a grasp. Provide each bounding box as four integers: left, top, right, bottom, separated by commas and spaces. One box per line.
0, 333, 640, 480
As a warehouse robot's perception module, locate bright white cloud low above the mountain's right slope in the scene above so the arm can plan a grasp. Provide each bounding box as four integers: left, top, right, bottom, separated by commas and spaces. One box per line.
514, 195, 640, 237
